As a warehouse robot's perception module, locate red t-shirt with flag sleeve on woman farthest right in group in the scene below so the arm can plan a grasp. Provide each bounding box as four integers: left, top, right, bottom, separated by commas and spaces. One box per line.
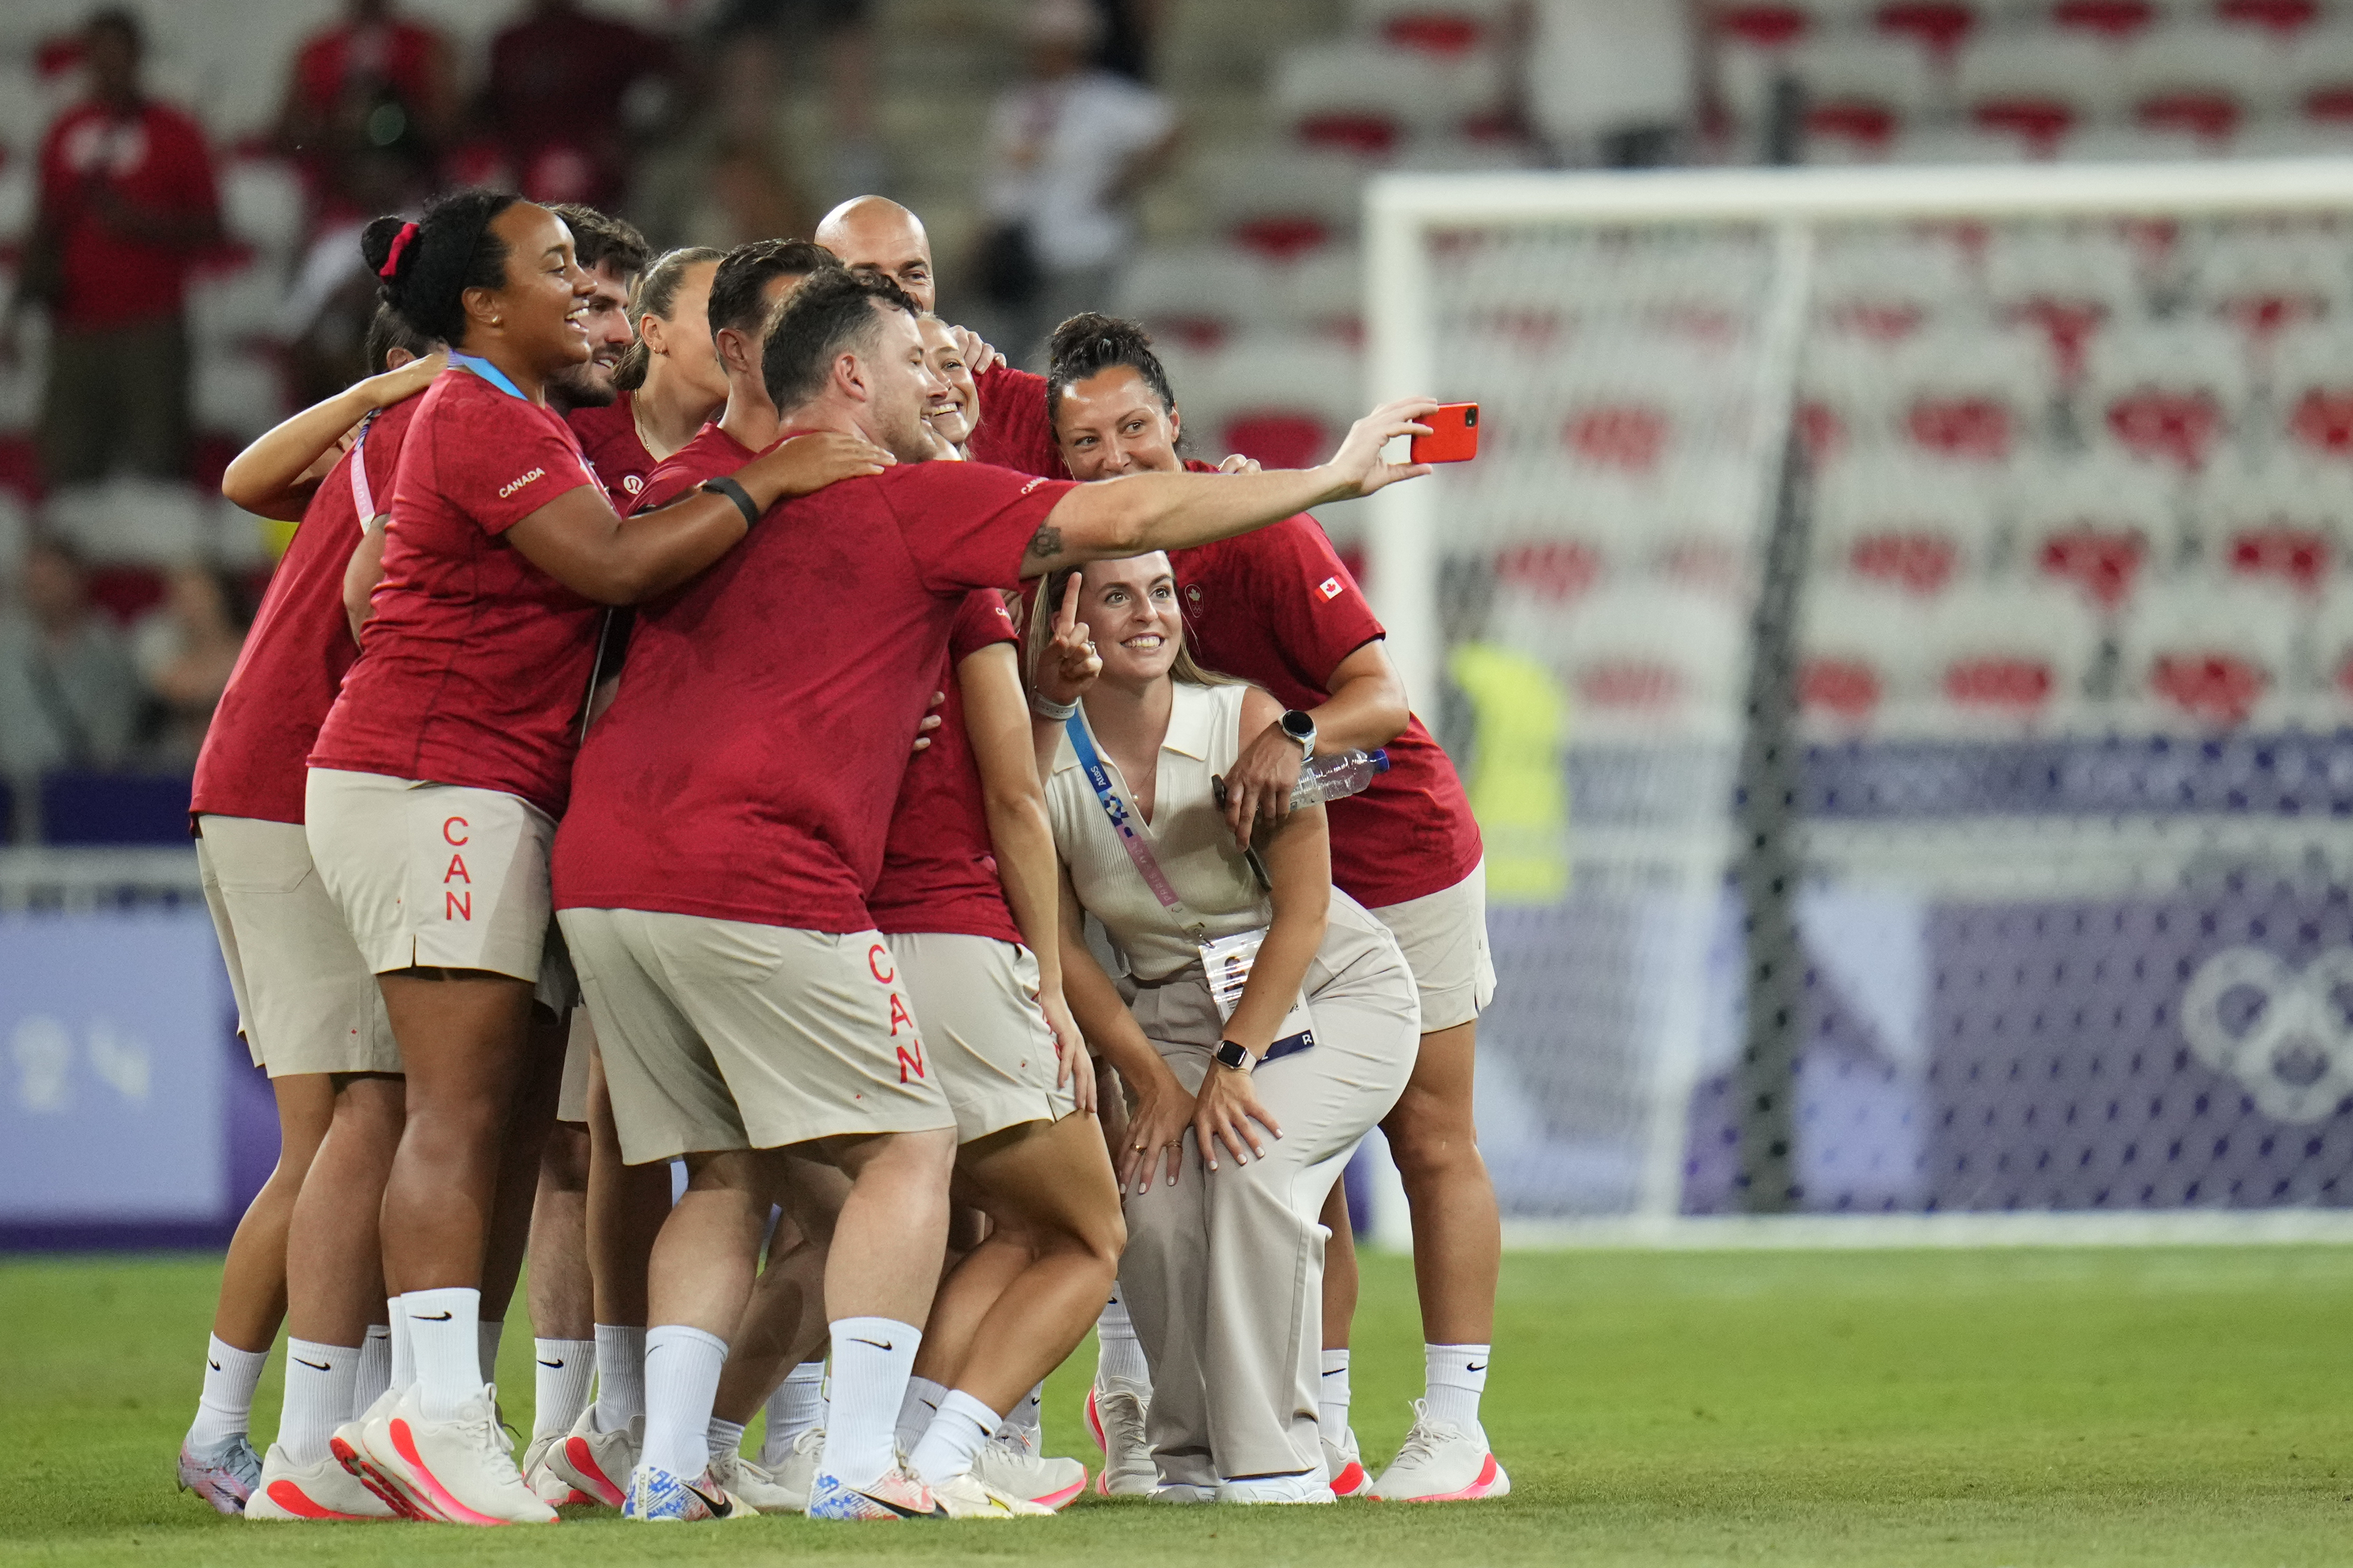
1169, 506, 1482, 909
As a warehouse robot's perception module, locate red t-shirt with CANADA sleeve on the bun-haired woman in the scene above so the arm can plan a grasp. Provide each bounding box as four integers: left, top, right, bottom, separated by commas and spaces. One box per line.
311, 372, 605, 817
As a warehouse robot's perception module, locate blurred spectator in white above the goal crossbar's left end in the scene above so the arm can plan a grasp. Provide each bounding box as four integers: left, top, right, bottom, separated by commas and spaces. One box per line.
1525, 0, 1701, 169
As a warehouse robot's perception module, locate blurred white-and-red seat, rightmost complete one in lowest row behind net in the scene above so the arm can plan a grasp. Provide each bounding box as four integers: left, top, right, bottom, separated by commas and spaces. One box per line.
2120, 577, 2299, 730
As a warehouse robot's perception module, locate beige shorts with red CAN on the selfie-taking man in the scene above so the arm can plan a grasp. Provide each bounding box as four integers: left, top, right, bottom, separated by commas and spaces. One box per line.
560, 909, 955, 1165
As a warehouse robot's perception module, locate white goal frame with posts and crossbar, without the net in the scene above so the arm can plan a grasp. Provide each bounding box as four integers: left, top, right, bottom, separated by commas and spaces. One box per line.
1365, 158, 2353, 1248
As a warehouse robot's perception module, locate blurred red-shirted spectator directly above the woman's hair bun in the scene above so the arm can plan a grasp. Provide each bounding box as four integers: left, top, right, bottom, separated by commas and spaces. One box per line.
278, 0, 456, 216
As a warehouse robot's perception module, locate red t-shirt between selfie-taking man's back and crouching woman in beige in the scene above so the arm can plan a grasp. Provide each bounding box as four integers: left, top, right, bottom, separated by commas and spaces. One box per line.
866, 589, 1021, 942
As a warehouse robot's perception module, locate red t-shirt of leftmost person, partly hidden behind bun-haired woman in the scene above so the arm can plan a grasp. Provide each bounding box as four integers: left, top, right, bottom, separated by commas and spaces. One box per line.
188, 398, 424, 822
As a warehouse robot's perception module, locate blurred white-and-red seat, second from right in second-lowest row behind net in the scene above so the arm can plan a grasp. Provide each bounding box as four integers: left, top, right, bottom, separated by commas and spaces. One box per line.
2014, 462, 2181, 610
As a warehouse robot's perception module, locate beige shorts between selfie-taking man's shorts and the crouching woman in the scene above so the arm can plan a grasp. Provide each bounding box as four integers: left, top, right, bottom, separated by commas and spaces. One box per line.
885, 932, 1078, 1144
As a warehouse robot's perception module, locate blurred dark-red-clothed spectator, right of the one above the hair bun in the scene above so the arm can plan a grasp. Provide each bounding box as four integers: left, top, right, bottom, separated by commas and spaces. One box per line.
482, 0, 678, 207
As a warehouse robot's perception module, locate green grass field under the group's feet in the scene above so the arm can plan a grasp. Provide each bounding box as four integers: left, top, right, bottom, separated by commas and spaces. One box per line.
0, 1248, 2353, 1568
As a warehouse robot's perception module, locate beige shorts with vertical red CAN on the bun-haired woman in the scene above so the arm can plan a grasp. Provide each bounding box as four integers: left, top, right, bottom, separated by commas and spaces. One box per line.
304, 768, 572, 1012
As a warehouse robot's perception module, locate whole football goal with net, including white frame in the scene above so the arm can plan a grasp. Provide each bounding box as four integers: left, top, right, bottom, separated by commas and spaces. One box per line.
1367, 160, 2353, 1227
